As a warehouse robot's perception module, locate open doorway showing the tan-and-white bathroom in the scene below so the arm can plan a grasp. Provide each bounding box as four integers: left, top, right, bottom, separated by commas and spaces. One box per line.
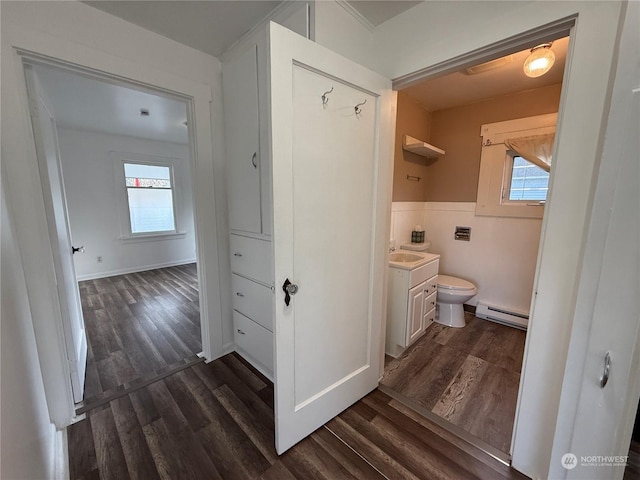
380, 35, 569, 462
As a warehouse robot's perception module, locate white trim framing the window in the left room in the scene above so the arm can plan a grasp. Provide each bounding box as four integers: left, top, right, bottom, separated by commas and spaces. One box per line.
109, 151, 187, 239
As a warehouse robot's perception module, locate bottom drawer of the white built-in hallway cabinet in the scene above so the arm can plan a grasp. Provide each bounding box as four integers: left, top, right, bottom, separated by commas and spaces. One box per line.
233, 312, 273, 374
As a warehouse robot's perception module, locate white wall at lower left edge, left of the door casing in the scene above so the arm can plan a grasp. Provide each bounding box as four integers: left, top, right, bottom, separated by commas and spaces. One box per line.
0, 179, 60, 479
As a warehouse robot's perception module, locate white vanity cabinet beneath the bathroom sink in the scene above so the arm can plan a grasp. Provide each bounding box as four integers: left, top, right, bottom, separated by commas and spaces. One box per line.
385, 254, 440, 357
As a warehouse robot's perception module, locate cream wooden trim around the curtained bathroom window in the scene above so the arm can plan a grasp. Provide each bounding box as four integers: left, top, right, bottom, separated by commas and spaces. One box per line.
476, 113, 558, 218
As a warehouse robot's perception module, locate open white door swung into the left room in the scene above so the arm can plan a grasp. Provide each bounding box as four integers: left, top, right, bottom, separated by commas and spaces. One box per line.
25, 66, 87, 403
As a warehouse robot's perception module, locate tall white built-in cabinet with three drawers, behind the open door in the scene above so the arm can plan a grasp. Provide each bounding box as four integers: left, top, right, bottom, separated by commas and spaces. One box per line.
223, 40, 274, 379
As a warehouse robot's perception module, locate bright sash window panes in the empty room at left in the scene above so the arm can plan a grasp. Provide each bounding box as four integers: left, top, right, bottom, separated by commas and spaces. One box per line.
124, 163, 176, 234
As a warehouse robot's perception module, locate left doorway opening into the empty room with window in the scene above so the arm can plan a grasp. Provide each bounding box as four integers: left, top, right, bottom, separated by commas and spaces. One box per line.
26, 63, 203, 413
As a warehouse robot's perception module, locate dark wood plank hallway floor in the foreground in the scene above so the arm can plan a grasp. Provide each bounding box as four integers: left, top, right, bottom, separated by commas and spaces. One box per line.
68, 354, 526, 480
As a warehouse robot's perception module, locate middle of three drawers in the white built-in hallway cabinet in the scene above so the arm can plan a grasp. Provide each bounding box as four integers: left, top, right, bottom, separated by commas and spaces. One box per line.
231, 274, 273, 332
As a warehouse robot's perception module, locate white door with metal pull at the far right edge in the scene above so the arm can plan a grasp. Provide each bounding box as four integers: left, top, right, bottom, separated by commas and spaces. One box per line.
550, 2, 640, 479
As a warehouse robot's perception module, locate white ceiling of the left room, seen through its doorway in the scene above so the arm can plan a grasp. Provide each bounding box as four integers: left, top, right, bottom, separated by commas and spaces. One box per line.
34, 66, 187, 144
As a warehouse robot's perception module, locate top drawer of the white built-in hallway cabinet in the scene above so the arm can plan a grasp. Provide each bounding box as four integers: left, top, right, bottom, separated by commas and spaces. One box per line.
229, 235, 273, 285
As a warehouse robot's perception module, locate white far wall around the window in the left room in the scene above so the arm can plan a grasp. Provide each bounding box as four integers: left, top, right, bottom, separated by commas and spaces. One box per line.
58, 127, 196, 280
